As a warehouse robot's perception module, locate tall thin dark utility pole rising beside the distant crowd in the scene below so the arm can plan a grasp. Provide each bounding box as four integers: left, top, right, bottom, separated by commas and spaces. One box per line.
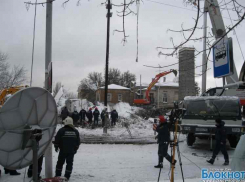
103, 0, 112, 133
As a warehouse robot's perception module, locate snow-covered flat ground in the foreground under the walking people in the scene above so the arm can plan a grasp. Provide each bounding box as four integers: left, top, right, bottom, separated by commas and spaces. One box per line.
0, 137, 234, 182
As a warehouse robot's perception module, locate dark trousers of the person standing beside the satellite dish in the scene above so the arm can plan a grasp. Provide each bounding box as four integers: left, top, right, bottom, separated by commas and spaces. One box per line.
55, 152, 74, 179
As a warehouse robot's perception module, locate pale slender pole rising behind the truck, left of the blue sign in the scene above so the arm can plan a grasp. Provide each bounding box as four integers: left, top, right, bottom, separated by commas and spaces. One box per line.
202, 1, 208, 93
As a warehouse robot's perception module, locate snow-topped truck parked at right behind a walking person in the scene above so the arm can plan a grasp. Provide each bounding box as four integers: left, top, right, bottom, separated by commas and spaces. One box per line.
181, 96, 245, 148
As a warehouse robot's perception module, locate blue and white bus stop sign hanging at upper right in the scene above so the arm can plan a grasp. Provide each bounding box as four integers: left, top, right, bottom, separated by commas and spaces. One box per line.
213, 37, 233, 78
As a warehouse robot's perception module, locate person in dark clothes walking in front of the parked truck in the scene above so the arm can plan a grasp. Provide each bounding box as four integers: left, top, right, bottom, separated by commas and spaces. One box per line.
207, 118, 229, 166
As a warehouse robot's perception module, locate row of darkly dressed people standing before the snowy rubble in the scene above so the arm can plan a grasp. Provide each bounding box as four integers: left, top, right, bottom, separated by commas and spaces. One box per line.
61, 107, 118, 127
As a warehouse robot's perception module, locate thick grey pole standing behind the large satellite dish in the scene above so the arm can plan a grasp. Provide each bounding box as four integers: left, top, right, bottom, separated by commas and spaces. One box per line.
45, 0, 53, 178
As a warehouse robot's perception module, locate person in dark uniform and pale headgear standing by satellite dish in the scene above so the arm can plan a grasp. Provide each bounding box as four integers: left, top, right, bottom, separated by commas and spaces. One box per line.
53, 117, 80, 180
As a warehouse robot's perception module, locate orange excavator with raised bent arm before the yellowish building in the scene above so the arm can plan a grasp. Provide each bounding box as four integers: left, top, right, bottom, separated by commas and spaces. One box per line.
134, 70, 177, 105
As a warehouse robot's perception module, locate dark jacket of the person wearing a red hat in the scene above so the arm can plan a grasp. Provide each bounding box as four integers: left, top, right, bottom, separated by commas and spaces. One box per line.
156, 122, 170, 144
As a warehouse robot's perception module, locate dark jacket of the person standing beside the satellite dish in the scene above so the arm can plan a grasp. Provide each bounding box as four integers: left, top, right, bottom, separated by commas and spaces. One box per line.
54, 125, 80, 153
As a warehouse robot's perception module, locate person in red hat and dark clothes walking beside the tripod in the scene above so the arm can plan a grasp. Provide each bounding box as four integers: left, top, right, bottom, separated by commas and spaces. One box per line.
153, 116, 176, 168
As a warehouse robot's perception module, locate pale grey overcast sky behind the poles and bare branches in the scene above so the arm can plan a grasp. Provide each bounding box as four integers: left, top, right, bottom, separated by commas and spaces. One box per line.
0, 0, 245, 92
